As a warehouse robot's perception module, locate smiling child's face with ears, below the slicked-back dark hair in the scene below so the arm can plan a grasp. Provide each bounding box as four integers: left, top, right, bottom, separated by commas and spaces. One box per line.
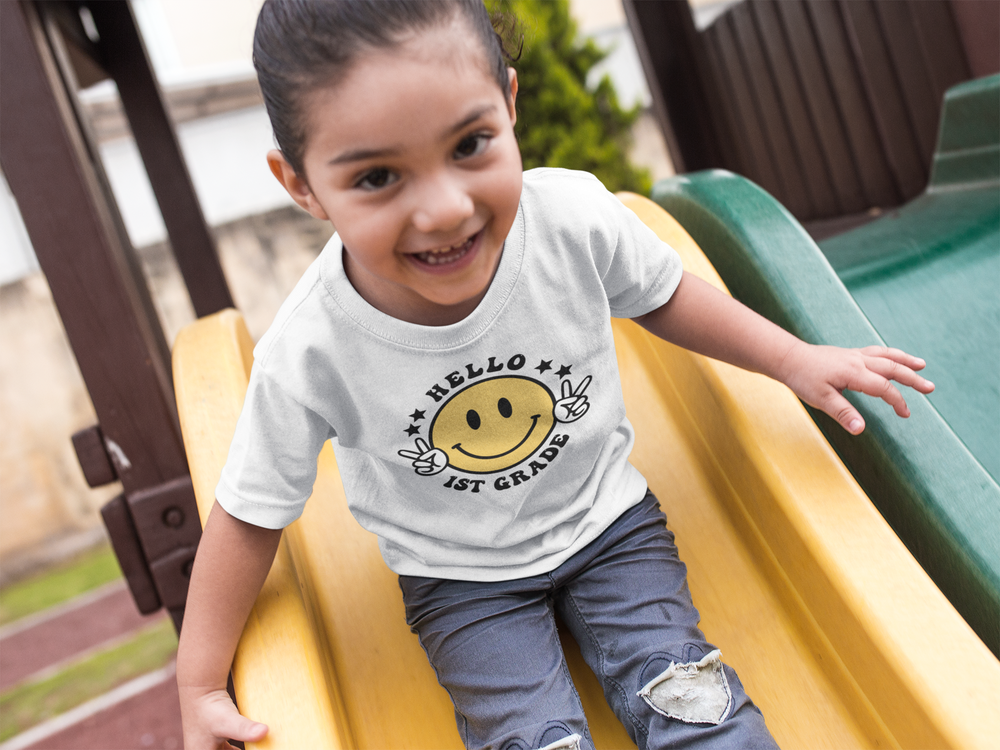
268, 20, 522, 325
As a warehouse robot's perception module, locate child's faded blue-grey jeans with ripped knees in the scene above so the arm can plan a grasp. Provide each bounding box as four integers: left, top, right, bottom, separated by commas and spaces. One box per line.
400, 493, 777, 750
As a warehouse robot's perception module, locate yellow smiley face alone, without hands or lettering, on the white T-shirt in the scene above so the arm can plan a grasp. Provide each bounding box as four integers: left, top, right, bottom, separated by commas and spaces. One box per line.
430, 375, 555, 474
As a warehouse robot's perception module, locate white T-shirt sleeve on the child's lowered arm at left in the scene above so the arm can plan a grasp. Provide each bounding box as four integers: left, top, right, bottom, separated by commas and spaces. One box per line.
215, 364, 333, 529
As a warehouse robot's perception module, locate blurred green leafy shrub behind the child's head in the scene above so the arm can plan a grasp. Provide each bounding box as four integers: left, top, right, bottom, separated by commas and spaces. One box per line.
487, 0, 652, 195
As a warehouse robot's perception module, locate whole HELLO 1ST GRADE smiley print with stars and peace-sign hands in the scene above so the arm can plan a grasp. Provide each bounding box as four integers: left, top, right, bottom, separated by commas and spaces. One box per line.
399, 354, 591, 492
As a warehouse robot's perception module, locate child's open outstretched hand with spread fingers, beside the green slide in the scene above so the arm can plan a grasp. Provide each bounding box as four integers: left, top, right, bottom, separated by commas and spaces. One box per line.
779, 341, 934, 435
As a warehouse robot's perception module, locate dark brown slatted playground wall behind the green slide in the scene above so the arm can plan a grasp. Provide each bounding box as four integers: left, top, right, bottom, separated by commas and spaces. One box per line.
623, 0, 1000, 229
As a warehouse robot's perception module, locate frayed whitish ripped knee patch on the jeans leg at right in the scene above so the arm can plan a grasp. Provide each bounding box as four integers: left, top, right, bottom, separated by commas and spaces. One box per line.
637, 649, 733, 724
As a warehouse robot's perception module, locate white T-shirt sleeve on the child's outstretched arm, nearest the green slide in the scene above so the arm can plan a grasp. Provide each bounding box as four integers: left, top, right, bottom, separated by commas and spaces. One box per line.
601, 189, 684, 318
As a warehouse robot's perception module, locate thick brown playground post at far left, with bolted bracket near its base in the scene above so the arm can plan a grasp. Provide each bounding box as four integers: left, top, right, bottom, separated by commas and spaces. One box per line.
0, 0, 200, 621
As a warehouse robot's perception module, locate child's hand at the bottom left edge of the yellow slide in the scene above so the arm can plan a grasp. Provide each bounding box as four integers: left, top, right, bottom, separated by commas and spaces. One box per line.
179, 687, 267, 750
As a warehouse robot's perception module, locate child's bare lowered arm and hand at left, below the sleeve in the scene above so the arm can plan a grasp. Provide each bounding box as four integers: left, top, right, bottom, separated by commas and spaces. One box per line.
177, 501, 281, 750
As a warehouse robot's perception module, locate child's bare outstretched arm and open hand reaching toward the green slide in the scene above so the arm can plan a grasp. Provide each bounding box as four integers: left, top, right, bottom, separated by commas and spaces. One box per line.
635, 273, 934, 435
